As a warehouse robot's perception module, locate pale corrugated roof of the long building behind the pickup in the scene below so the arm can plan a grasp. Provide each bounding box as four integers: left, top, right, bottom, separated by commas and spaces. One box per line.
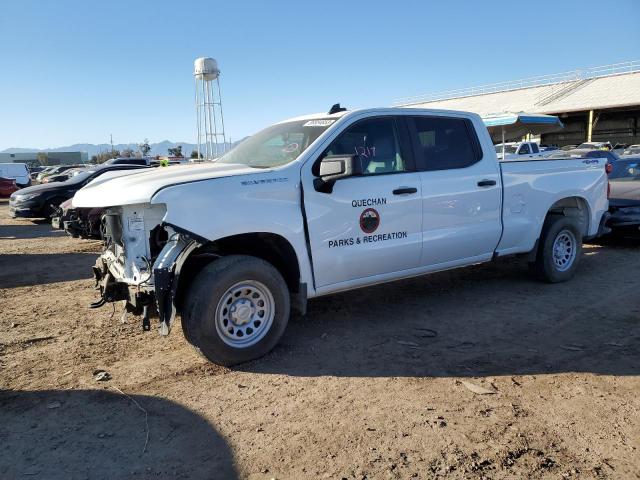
404, 72, 640, 115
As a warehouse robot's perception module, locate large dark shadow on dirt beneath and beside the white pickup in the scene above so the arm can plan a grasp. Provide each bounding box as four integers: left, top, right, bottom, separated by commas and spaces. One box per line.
239, 248, 640, 377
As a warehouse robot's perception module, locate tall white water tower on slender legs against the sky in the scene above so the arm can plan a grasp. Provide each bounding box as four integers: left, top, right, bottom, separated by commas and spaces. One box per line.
193, 57, 227, 160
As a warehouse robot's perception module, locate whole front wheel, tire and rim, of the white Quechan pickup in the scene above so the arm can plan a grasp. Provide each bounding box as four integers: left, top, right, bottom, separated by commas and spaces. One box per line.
182, 255, 289, 366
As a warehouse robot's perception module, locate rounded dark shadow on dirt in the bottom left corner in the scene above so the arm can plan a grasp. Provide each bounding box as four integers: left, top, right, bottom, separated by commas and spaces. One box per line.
0, 390, 238, 479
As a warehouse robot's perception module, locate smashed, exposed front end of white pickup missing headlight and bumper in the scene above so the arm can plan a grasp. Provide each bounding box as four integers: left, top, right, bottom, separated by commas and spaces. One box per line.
91, 204, 202, 335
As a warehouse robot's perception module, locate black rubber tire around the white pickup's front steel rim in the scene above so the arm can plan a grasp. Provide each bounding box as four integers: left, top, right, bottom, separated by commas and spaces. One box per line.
181, 255, 290, 366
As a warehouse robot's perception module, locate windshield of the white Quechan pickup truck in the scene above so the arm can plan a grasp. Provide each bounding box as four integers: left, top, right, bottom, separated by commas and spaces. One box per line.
217, 118, 336, 168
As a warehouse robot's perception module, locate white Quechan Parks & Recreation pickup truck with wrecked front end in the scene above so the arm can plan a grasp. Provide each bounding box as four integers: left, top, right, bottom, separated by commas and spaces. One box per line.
73, 106, 608, 365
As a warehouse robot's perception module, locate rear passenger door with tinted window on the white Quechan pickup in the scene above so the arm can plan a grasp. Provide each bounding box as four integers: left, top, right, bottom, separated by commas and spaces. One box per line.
409, 115, 502, 267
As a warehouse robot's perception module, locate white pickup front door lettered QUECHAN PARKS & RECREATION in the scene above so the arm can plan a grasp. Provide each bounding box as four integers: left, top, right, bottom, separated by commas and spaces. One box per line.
304, 116, 422, 289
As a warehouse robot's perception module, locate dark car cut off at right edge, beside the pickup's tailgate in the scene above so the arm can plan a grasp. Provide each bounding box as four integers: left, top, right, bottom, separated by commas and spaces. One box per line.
607, 157, 640, 236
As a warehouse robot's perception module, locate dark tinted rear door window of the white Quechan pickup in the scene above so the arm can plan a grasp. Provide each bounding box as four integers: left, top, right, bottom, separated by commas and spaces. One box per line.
410, 117, 482, 170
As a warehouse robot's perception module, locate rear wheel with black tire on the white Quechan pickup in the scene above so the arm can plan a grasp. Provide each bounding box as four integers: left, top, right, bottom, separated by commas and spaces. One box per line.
529, 215, 582, 283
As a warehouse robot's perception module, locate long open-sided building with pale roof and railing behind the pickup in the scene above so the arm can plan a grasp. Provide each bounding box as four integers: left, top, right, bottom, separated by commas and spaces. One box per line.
396, 61, 640, 146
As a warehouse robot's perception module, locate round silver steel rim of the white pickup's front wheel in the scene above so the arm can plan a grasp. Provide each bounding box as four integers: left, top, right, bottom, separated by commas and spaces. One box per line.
215, 280, 275, 348
